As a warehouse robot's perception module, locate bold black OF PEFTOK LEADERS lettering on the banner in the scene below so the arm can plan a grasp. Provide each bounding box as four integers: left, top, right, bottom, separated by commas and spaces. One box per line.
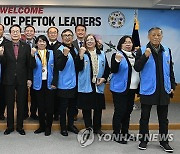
1, 16, 101, 26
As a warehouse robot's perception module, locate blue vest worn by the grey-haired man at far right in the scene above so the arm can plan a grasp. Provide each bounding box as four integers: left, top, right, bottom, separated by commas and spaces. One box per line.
140, 46, 171, 95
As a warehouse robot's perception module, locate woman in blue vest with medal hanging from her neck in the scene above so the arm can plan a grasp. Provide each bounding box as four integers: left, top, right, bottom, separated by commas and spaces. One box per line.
31, 35, 58, 136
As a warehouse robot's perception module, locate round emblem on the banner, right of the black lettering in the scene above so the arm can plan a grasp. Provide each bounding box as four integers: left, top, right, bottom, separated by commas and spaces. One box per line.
108, 11, 125, 28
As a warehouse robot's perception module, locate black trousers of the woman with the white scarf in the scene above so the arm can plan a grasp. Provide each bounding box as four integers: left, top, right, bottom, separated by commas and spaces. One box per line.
112, 89, 135, 134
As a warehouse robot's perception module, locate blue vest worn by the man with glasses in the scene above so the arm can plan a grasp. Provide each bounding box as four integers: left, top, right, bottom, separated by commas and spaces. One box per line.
58, 45, 78, 89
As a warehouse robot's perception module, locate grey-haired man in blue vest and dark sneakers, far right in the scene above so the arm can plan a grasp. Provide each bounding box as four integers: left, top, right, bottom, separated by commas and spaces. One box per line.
134, 27, 176, 153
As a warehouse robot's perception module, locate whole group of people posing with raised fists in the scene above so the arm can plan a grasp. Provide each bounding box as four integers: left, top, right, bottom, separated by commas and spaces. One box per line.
0, 24, 176, 152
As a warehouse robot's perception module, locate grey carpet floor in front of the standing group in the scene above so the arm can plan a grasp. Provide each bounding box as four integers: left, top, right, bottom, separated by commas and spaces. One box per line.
0, 130, 180, 154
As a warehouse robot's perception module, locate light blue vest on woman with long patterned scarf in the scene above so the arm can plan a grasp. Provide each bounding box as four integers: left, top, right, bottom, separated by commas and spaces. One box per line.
78, 51, 106, 94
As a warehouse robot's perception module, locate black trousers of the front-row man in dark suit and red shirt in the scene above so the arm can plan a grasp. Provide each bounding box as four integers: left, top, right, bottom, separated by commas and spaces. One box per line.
5, 85, 27, 129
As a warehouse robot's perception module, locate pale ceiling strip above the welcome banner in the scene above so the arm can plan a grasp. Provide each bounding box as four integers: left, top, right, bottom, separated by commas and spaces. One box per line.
1, 0, 180, 10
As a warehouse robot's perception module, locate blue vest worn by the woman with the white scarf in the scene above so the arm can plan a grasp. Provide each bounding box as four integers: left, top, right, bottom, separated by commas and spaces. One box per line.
110, 51, 129, 93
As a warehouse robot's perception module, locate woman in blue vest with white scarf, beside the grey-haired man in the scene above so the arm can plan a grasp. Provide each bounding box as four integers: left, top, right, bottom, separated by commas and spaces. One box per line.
110, 35, 139, 144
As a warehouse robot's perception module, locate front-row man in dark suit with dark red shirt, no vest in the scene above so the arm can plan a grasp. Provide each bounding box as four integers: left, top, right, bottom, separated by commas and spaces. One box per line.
0, 24, 32, 135
